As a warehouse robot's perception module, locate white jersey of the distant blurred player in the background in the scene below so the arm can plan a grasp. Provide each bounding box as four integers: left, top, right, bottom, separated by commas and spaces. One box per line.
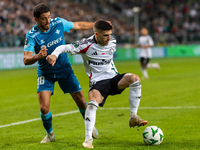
138, 35, 154, 58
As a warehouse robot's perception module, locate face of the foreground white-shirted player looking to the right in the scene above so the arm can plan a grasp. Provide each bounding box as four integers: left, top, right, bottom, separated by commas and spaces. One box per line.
96, 30, 112, 46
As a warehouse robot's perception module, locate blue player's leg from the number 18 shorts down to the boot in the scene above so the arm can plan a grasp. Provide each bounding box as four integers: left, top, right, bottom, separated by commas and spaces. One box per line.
37, 76, 55, 143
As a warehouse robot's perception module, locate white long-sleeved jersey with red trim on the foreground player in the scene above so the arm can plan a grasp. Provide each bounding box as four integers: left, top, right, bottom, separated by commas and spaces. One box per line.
52, 35, 118, 84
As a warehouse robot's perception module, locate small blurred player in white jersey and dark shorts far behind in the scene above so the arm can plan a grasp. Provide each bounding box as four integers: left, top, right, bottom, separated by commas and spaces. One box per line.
133, 28, 160, 79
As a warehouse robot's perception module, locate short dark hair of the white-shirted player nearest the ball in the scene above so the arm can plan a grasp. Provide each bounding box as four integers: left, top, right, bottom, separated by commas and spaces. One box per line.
94, 20, 113, 31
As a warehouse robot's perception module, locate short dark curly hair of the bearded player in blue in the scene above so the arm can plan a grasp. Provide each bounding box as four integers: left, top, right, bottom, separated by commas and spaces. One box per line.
33, 3, 50, 18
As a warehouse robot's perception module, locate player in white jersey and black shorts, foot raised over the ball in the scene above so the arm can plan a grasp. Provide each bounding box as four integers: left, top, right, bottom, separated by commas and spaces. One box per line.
46, 20, 148, 148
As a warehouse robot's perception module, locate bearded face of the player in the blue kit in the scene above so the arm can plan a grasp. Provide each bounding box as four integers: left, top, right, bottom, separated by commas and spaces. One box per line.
36, 12, 51, 32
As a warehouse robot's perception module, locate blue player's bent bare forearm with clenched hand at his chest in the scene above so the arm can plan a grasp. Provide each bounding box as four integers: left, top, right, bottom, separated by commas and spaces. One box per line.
23, 47, 47, 65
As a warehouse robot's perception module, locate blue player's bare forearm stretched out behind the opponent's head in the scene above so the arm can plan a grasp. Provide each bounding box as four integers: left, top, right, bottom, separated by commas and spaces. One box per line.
72, 22, 94, 30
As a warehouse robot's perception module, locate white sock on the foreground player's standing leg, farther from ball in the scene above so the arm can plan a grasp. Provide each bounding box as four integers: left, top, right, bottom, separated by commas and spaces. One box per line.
85, 101, 99, 140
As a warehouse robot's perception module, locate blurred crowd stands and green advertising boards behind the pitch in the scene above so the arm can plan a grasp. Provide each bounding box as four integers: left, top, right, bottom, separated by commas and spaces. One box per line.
0, 0, 200, 70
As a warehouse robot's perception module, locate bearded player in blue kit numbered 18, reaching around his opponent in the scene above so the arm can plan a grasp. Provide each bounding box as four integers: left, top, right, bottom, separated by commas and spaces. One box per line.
23, 4, 98, 143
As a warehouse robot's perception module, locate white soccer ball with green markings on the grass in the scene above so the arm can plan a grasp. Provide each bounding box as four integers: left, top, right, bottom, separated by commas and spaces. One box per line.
142, 126, 164, 145
